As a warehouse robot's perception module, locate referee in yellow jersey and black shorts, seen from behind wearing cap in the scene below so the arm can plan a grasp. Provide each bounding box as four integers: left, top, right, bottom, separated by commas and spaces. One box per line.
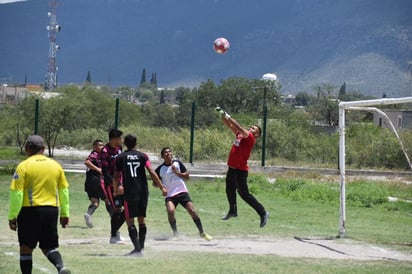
8, 135, 70, 274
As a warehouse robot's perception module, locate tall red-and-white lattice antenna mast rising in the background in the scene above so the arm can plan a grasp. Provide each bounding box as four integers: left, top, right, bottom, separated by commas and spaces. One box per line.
44, 0, 61, 90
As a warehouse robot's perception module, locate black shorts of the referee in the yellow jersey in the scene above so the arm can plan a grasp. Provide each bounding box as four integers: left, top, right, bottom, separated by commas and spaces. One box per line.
17, 206, 59, 250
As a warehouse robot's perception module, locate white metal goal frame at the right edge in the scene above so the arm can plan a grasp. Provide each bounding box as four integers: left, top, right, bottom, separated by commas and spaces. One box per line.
338, 97, 412, 238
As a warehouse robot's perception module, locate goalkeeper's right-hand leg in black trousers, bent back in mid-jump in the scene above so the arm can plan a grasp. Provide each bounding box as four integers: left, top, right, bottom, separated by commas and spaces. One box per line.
236, 170, 269, 227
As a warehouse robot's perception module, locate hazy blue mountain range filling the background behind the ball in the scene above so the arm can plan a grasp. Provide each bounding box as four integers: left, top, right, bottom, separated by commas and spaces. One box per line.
0, 0, 412, 97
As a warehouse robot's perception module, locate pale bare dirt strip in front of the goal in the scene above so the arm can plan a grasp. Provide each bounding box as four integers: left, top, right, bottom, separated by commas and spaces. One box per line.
55, 235, 412, 262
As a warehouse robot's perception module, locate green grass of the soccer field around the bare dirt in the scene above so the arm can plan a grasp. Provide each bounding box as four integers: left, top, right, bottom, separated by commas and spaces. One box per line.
0, 174, 412, 273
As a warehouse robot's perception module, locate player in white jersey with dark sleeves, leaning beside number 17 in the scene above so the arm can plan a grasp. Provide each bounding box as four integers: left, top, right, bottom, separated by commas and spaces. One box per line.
156, 147, 212, 241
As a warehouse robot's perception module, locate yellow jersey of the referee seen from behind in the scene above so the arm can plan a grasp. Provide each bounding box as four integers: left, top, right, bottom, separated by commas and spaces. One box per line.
10, 154, 69, 217
